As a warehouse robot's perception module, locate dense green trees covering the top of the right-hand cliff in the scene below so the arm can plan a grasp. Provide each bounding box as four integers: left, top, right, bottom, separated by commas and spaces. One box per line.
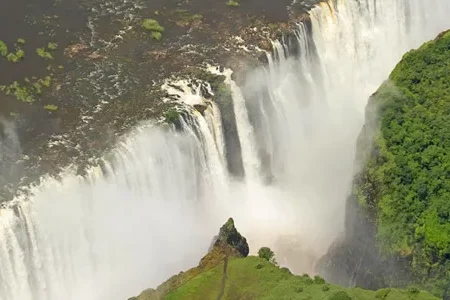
355, 32, 450, 294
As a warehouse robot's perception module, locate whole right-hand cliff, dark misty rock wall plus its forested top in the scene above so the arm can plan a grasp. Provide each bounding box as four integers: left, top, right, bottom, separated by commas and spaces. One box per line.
321, 32, 450, 295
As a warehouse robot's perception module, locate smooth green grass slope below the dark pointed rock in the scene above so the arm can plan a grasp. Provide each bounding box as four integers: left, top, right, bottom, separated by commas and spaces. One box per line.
164, 256, 438, 300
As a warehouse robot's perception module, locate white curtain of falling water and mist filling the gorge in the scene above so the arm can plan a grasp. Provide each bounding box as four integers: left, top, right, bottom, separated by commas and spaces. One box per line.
0, 0, 450, 300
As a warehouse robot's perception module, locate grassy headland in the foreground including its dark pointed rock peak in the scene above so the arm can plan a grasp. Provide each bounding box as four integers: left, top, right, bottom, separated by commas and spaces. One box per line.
129, 219, 437, 300
